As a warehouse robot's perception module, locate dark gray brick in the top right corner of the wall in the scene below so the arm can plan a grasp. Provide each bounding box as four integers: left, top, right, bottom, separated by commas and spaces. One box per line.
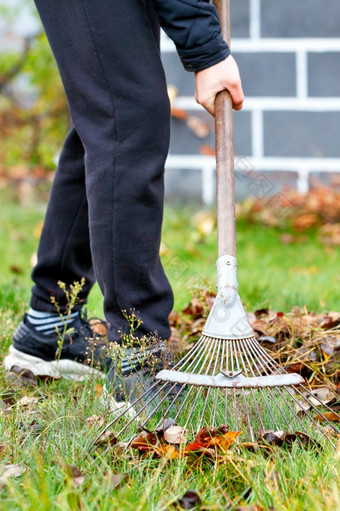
261, 0, 340, 37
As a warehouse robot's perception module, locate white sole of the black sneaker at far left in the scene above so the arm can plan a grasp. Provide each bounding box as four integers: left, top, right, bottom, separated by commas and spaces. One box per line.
4, 346, 105, 381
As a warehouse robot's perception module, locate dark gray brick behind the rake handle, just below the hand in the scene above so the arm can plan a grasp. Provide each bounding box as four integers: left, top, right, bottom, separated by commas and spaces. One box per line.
170, 110, 251, 155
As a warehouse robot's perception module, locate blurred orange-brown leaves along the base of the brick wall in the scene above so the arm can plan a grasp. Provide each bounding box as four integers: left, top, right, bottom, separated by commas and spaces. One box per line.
237, 187, 340, 245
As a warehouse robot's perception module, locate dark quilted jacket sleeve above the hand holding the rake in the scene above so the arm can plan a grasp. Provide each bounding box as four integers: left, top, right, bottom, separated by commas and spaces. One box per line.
151, 0, 230, 71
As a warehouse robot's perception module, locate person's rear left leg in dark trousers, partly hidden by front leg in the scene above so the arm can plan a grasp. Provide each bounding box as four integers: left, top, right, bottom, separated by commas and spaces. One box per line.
31, 127, 94, 313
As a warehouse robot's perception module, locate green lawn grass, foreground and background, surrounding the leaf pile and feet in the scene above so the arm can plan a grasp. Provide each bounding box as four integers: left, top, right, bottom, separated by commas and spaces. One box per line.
0, 191, 340, 511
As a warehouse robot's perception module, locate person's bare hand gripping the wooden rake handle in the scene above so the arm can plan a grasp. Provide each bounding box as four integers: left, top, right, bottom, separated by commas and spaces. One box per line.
195, 55, 244, 115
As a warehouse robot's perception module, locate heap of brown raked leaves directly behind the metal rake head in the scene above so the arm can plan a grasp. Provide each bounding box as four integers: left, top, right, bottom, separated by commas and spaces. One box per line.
170, 292, 340, 390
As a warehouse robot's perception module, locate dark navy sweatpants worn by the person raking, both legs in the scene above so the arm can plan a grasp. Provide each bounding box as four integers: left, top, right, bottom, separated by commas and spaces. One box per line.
31, 0, 173, 341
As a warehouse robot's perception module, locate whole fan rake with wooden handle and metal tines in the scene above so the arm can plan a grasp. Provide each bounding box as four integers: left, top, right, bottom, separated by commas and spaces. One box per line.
98, 0, 340, 446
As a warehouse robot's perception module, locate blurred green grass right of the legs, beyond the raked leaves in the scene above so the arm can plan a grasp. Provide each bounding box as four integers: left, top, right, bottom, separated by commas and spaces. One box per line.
163, 209, 340, 312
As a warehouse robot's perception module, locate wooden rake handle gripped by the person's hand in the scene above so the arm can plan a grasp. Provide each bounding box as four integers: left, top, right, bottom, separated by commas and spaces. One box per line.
214, 0, 236, 257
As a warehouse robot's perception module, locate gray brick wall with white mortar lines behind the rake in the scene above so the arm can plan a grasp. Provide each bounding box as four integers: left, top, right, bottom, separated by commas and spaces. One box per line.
162, 0, 340, 203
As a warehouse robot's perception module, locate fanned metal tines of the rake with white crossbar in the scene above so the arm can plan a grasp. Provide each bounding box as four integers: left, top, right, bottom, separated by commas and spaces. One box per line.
97, 335, 340, 445
